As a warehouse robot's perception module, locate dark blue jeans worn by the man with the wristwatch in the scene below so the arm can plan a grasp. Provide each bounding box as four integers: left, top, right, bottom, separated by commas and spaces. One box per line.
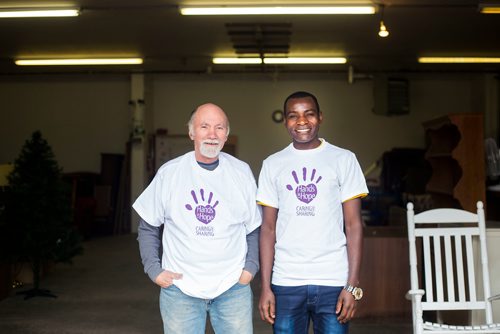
272, 285, 349, 334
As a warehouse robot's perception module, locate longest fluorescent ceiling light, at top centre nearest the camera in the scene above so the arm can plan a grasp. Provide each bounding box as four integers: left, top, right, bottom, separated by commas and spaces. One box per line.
180, 6, 375, 15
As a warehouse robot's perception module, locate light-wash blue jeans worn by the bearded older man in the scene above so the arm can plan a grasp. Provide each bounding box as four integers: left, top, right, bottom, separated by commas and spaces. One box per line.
160, 283, 253, 334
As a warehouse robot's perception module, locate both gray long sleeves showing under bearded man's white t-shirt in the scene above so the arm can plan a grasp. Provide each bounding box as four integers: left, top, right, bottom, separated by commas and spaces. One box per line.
137, 219, 260, 282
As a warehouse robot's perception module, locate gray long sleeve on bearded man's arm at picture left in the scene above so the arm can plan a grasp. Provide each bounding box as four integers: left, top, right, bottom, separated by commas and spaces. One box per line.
137, 219, 163, 282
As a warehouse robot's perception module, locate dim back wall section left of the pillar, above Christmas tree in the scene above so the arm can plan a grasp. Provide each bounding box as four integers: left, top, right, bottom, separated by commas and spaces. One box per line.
0, 75, 130, 172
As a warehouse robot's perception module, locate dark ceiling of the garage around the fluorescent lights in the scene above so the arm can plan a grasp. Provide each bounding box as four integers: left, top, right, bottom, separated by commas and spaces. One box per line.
0, 0, 500, 75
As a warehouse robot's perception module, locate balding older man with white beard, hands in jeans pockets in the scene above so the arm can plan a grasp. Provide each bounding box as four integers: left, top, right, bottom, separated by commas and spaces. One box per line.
133, 103, 261, 334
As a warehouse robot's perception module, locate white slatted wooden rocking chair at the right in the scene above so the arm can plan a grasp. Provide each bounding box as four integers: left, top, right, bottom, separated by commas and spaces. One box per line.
407, 202, 500, 334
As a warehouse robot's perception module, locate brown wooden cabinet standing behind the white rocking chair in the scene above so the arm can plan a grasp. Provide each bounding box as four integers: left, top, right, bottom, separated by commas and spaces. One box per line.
423, 113, 485, 212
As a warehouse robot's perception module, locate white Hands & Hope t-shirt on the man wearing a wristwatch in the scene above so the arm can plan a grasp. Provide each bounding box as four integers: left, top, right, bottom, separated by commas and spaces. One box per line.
257, 139, 368, 286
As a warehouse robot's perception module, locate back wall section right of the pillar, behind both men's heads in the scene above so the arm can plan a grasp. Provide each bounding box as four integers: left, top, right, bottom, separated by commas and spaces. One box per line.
152, 75, 478, 173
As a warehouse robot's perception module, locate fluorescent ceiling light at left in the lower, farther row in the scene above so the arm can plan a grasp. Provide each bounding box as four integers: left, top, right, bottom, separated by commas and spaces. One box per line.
15, 58, 143, 66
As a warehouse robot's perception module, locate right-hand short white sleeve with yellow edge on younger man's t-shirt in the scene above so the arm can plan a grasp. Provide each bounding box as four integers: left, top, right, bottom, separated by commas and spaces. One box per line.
340, 152, 368, 202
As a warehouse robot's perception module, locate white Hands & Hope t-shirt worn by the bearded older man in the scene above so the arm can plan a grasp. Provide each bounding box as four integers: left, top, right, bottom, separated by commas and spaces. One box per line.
133, 152, 262, 299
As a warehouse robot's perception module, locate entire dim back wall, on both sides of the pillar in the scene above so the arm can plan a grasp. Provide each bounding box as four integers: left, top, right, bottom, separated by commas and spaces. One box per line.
0, 74, 490, 174
